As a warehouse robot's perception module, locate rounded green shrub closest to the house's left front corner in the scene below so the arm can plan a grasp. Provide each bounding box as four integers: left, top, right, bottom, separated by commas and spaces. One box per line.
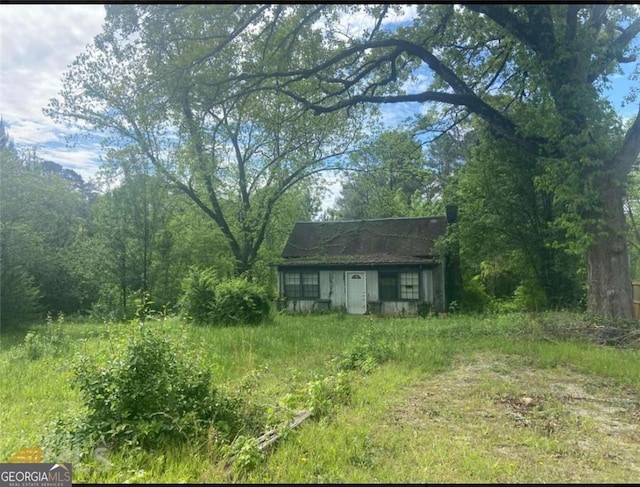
210, 278, 271, 325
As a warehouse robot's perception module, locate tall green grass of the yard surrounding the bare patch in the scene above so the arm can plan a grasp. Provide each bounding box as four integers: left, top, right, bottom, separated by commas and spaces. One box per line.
0, 313, 640, 483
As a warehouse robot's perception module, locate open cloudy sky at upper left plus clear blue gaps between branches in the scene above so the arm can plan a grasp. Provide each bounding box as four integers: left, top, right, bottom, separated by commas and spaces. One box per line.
0, 4, 637, 195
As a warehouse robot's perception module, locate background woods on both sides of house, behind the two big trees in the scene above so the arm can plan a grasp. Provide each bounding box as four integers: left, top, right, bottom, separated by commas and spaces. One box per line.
7, 117, 636, 326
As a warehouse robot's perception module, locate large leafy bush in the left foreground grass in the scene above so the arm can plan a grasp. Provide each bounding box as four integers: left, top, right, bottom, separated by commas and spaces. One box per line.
57, 325, 255, 448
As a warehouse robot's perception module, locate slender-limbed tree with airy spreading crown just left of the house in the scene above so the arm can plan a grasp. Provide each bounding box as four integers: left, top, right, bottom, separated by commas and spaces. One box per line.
47, 4, 358, 274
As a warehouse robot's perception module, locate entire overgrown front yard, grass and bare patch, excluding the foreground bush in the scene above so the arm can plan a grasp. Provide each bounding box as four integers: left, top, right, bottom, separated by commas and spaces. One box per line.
0, 313, 640, 483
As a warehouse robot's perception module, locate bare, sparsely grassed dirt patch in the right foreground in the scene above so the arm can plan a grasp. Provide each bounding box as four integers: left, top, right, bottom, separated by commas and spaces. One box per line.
384, 354, 640, 482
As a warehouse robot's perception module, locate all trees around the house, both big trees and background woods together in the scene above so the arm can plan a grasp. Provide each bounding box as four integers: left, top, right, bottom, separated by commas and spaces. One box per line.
0, 4, 640, 323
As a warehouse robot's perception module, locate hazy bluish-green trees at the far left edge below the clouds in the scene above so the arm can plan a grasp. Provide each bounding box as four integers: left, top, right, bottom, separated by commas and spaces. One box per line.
0, 139, 94, 318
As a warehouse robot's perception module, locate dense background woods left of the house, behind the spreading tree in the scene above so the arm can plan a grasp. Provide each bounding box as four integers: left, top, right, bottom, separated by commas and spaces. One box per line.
0, 123, 315, 327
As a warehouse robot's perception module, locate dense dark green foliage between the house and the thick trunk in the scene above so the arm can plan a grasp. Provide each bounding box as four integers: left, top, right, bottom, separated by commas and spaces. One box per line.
455, 124, 584, 309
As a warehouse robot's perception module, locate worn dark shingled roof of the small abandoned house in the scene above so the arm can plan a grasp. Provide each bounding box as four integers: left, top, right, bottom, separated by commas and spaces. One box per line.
280, 217, 447, 266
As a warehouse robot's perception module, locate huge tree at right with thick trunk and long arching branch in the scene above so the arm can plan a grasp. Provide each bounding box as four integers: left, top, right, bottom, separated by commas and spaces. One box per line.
235, 3, 640, 318
